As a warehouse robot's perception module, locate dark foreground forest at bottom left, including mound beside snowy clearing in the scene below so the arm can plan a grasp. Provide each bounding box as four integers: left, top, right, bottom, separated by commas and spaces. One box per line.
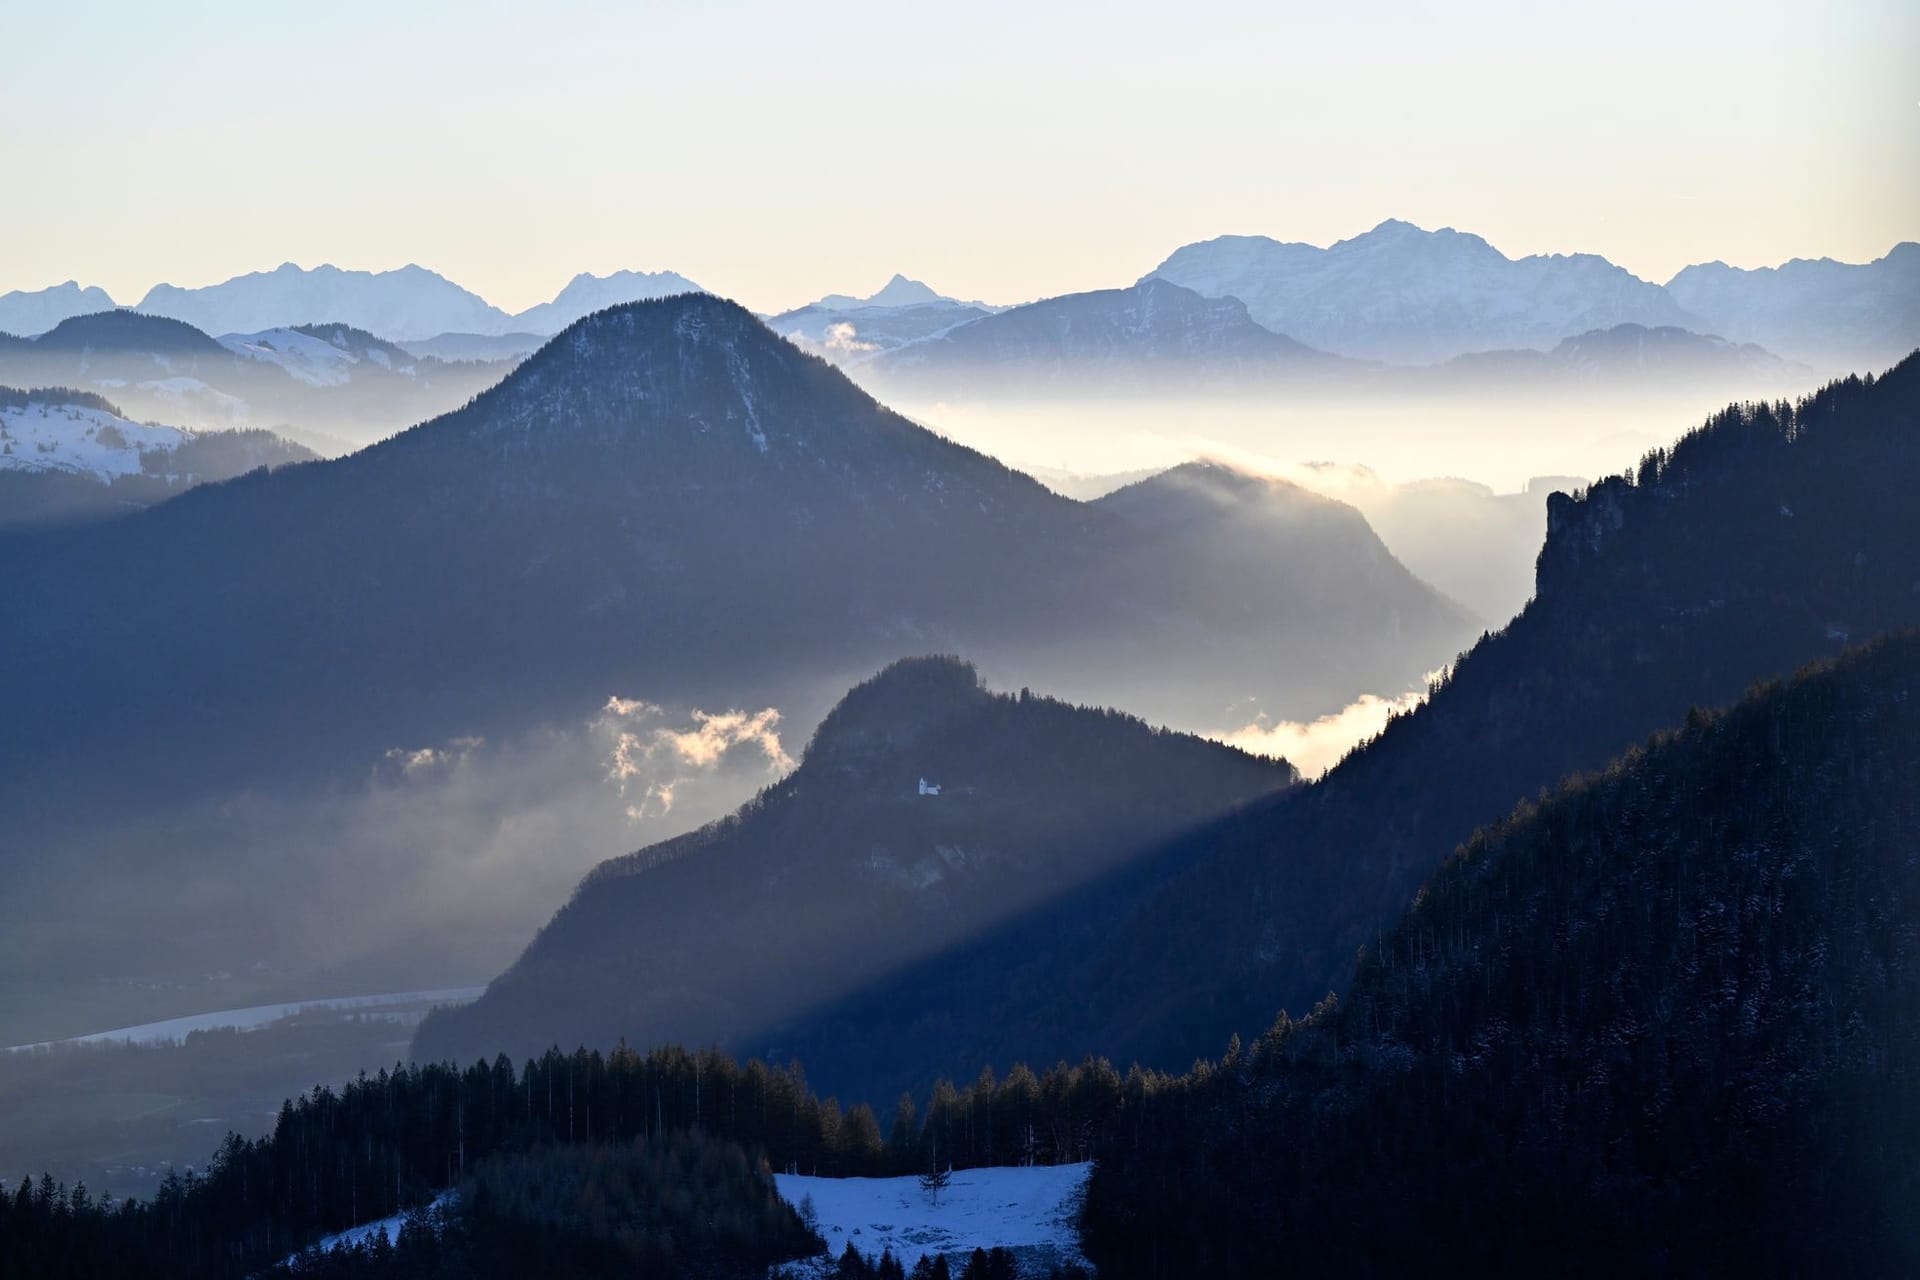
0, 1046, 1128, 1280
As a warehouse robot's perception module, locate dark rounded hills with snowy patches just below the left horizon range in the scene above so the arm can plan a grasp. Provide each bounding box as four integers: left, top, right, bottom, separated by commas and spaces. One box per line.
0, 311, 511, 453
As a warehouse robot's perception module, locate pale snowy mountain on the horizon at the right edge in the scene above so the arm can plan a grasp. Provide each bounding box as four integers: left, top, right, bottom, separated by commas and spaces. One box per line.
1667, 240, 1920, 372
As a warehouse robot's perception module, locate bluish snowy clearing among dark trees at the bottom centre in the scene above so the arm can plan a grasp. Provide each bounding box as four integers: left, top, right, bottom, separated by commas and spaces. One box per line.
774, 1163, 1092, 1272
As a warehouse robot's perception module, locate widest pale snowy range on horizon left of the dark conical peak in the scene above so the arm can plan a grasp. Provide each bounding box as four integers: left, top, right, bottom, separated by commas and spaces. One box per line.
138, 263, 513, 340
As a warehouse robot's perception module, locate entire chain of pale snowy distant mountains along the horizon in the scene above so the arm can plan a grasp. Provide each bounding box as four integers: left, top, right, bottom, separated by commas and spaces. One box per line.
0, 219, 1920, 378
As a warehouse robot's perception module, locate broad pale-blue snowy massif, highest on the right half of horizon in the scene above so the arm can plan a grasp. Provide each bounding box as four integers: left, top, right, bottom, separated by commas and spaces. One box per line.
1148, 221, 1701, 365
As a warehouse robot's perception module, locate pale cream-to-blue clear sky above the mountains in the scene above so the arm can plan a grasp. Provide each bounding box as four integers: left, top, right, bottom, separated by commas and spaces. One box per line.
0, 0, 1920, 311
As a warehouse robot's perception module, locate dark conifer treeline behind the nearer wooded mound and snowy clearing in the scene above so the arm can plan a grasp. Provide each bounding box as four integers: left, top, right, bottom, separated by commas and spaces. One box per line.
0, 1046, 1136, 1276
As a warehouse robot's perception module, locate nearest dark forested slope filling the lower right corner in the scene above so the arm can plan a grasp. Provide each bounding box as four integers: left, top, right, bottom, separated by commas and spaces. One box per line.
1085, 633, 1920, 1280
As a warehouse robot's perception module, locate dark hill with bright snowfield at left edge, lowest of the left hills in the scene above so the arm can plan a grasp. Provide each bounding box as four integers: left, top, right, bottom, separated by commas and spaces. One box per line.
0, 388, 313, 530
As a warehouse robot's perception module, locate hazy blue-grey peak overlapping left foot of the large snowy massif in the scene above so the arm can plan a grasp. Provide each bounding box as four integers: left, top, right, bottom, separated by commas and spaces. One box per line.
860, 278, 1342, 395
